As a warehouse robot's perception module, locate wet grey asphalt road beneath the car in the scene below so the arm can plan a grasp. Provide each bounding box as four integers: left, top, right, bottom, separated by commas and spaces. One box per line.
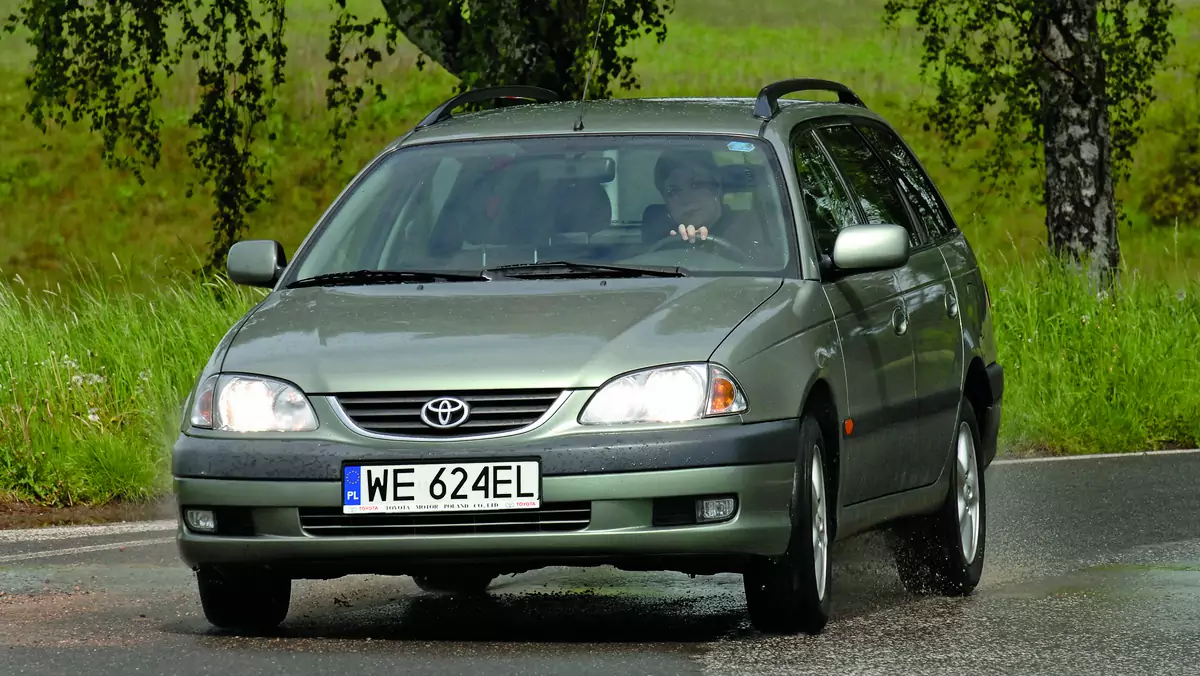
0, 454, 1200, 676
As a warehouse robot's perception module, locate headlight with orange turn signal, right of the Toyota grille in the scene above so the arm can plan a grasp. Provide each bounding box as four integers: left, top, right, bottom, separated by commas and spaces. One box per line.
580, 364, 748, 425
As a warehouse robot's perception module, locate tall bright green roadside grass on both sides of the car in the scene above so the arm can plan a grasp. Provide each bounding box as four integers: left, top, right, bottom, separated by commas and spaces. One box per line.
0, 253, 1200, 504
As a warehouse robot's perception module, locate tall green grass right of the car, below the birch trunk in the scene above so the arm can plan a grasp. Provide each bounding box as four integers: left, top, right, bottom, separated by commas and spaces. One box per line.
985, 247, 1200, 455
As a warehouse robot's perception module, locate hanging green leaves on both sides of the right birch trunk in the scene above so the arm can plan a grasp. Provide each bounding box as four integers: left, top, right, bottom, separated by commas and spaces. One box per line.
886, 0, 1175, 198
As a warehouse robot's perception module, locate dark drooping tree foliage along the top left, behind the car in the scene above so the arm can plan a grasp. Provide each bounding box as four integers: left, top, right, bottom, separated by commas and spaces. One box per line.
5, 0, 670, 273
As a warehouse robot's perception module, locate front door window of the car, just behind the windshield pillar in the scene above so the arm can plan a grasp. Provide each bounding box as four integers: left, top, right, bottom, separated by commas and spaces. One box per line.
792, 131, 858, 256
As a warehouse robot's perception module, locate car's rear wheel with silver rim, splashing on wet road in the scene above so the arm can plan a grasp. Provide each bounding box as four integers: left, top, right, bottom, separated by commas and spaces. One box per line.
893, 397, 988, 597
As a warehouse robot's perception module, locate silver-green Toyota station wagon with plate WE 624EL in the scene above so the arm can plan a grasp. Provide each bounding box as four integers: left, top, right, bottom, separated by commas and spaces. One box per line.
172, 79, 1003, 633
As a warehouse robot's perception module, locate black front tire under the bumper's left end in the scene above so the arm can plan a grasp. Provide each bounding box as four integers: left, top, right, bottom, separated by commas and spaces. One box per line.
196, 568, 292, 632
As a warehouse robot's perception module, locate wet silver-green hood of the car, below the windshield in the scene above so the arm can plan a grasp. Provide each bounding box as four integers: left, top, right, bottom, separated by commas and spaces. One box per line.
222, 277, 782, 394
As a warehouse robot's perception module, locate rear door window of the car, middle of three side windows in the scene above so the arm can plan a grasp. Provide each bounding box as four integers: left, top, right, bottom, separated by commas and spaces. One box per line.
817, 125, 920, 247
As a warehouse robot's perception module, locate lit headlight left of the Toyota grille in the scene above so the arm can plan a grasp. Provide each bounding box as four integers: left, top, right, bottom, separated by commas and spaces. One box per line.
191, 376, 317, 432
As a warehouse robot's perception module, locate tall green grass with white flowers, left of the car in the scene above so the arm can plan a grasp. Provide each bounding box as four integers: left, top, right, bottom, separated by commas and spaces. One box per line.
0, 261, 260, 505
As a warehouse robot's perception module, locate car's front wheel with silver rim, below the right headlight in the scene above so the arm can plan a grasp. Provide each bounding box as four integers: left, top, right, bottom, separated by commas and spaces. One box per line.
743, 415, 833, 634
